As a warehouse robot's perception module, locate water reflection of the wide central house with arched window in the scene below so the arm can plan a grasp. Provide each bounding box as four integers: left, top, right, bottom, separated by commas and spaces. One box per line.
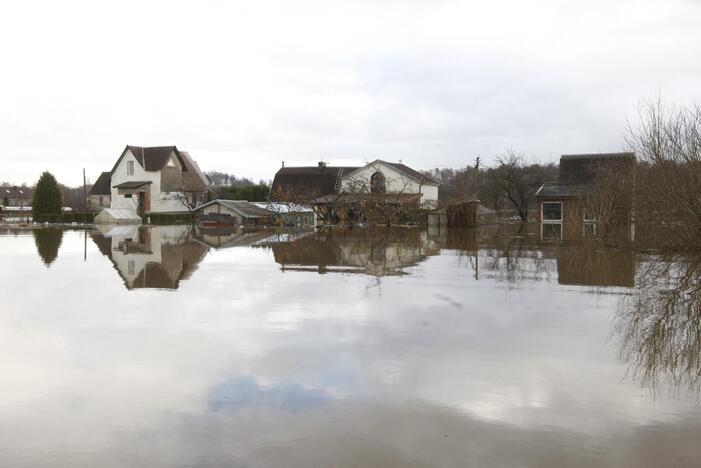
268, 229, 439, 276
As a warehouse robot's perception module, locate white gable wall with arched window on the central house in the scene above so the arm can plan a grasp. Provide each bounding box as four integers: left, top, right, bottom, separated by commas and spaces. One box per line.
341, 161, 438, 204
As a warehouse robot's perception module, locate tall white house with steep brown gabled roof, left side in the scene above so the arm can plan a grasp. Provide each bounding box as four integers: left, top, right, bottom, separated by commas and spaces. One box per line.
110, 146, 209, 215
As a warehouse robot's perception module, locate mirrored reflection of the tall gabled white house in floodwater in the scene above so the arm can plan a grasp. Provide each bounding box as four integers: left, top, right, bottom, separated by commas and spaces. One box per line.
92, 226, 209, 289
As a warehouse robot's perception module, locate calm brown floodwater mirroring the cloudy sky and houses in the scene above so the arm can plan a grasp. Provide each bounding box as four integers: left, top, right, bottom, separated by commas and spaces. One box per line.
0, 226, 701, 468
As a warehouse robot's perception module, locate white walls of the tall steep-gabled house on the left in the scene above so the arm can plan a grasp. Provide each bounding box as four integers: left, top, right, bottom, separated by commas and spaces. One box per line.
110, 150, 188, 213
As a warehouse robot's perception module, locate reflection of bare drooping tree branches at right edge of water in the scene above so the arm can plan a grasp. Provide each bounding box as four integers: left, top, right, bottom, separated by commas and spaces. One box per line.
617, 258, 701, 394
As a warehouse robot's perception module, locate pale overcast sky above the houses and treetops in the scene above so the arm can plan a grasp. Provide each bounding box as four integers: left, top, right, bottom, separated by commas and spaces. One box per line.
0, 0, 701, 185
